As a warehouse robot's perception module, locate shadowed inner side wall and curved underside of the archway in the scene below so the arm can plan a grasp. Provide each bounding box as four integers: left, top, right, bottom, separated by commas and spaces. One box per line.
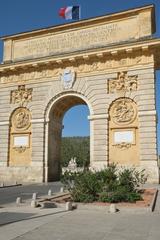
47, 95, 90, 181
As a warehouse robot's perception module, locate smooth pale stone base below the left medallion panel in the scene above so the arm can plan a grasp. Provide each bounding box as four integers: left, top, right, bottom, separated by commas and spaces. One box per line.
0, 166, 43, 183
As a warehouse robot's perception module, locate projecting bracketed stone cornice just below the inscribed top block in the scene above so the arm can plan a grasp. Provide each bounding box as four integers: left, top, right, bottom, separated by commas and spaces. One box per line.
0, 39, 160, 74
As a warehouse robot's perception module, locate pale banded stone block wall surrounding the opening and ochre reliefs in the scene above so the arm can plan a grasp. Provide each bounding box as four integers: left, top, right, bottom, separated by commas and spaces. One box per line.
0, 60, 158, 181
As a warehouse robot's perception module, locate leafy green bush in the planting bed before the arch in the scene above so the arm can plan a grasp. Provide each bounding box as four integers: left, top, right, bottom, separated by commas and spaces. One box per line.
62, 164, 147, 203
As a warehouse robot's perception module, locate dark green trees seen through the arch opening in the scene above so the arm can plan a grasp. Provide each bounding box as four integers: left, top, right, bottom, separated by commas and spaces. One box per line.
61, 137, 90, 167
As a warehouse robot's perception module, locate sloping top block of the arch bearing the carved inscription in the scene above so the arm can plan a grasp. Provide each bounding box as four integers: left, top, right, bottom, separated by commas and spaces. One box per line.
1, 5, 155, 63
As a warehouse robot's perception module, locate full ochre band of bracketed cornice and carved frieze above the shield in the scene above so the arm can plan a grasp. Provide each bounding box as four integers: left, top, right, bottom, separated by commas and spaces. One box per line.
0, 39, 160, 86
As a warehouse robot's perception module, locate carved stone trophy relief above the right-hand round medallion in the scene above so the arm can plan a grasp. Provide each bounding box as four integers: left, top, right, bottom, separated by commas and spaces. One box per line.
108, 72, 137, 93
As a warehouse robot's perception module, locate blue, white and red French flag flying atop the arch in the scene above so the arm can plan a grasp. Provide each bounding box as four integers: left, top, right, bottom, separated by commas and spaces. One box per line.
59, 6, 80, 20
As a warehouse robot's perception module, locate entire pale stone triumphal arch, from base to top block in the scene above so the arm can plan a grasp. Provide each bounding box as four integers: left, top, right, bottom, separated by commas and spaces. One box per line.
0, 5, 160, 182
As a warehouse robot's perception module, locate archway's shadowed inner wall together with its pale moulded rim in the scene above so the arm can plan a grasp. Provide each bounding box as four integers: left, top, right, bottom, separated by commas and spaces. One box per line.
45, 93, 90, 181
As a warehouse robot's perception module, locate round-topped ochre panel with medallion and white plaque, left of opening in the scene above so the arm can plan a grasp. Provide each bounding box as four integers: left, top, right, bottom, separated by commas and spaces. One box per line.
9, 107, 32, 166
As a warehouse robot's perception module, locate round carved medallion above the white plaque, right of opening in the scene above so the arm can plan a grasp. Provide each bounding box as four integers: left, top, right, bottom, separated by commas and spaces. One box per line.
112, 99, 136, 124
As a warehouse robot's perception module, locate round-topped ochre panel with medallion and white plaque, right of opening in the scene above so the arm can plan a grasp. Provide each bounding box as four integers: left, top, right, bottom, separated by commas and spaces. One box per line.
109, 98, 139, 166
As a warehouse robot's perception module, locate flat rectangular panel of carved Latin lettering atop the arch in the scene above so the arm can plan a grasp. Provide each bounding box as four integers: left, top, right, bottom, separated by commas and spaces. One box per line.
13, 17, 138, 60
